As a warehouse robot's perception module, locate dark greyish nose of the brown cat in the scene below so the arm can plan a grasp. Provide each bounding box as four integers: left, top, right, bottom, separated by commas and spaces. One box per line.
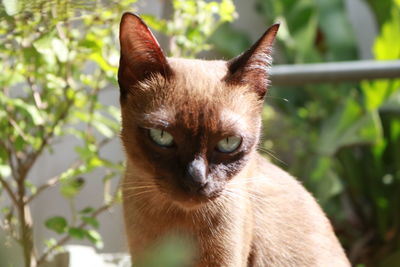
185, 157, 207, 193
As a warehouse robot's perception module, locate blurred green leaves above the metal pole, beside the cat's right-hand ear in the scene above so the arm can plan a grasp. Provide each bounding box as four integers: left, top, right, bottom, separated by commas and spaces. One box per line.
253, 0, 356, 63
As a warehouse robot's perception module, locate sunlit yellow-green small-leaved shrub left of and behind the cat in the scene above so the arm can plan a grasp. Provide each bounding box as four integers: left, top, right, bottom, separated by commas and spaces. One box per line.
0, 0, 231, 266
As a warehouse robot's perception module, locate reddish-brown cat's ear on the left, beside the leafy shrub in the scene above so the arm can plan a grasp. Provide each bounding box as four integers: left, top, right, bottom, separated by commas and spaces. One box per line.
118, 13, 172, 97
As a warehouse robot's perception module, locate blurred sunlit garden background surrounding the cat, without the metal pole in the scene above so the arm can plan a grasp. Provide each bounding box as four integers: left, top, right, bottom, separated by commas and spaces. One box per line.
0, 0, 400, 267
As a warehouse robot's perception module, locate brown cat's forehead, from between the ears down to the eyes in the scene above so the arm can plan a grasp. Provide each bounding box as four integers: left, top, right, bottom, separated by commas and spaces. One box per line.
131, 58, 262, 130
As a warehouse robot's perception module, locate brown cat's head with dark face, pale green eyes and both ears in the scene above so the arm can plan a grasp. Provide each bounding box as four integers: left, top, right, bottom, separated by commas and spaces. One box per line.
118, 13, 279, 208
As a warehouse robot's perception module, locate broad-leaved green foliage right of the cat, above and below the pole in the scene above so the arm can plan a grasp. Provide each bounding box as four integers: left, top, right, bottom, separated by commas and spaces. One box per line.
244, 0, 400, 266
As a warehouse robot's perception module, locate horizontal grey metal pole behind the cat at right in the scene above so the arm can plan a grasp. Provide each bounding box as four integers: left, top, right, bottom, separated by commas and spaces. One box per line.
270, 60, 400, 86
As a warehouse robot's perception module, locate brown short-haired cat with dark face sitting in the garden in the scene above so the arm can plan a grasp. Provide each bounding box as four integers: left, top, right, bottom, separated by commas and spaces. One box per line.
118, 13, 350, 267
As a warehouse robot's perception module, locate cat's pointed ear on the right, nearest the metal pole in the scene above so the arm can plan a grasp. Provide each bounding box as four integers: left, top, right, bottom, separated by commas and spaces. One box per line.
224, 24, 279, 98
